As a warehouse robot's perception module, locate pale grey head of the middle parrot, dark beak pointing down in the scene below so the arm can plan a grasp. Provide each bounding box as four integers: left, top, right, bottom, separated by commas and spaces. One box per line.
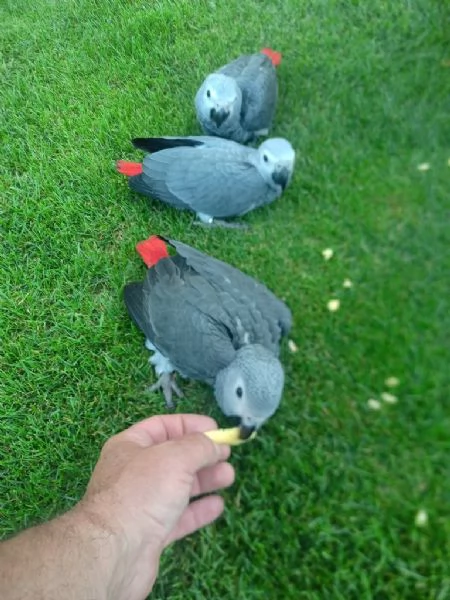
258, 138, 295, 193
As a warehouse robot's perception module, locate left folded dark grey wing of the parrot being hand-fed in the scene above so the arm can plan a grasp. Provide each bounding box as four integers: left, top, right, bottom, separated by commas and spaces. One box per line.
124, 257, 236, 383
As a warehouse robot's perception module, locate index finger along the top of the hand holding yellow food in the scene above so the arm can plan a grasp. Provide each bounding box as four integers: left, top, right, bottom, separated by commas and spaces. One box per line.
116, 414, 217, 448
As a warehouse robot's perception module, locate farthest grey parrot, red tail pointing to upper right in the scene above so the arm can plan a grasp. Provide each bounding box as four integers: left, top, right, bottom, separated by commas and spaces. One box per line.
195, 48, 281, 144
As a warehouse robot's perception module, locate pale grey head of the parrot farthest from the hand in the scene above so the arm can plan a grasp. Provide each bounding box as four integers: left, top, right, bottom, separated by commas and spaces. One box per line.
195, 73, 242, 129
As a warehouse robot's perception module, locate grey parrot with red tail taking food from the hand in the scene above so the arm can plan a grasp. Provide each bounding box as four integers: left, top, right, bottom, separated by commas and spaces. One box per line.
124, 236, 292, 439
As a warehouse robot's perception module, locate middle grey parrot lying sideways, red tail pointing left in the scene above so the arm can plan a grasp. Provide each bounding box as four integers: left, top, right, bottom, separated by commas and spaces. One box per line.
117, 136, 295, 226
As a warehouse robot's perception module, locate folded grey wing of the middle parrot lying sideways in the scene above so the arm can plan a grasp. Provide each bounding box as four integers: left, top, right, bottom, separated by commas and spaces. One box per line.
144, 144, 276, 217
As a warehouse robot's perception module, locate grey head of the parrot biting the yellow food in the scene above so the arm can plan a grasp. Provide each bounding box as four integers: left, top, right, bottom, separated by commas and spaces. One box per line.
214, 344, 284, 439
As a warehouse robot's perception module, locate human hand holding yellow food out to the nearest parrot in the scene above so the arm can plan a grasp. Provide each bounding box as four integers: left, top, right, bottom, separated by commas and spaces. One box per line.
78, 415, 234, 600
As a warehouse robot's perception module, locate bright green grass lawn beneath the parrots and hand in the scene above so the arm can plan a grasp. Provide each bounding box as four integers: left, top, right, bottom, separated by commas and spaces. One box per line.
0, 0, 450, 600
